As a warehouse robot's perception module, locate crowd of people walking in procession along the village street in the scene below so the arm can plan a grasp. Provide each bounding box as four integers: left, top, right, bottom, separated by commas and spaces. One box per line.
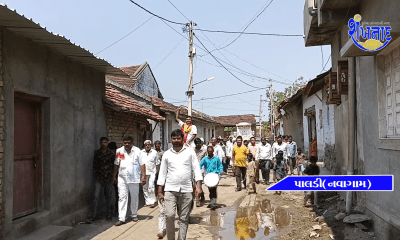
87, 110, 316, 239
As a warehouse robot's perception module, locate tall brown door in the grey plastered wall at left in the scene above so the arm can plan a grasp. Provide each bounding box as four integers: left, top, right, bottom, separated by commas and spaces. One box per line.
13, 99, 38, 218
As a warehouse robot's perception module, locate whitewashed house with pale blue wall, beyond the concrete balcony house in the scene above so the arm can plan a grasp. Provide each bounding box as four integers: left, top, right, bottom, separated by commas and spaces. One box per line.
277, 70, 336, 162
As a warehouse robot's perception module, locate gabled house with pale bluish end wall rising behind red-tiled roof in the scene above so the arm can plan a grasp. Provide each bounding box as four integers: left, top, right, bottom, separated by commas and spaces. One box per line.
106, 62, 163, 145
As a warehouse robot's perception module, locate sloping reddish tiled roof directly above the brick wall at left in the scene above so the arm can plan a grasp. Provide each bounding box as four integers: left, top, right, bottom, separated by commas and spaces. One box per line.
105, 86, 165, 121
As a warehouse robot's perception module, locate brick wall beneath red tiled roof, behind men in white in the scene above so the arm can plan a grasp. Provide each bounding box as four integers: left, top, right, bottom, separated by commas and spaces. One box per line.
105, 107, 151, 148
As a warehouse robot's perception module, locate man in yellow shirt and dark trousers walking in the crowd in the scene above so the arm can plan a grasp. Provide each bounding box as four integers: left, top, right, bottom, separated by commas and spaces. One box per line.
232, 136, 249, 191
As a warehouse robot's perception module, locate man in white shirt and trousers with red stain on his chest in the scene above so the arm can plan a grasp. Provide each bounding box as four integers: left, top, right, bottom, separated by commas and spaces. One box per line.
113, 136, 146, 226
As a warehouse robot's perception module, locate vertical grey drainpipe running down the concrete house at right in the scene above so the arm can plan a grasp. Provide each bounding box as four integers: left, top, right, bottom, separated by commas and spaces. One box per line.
346, 57, 356, 213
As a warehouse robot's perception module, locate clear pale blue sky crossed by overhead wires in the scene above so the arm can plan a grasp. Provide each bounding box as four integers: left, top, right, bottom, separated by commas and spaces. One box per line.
3, 0, 331, 120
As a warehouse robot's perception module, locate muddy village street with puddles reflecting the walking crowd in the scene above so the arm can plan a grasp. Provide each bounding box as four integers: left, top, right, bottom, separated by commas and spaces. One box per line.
65, 165, 376, 240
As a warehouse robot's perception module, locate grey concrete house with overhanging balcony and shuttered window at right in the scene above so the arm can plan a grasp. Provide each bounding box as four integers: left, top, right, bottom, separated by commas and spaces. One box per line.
303, 0, 400, 239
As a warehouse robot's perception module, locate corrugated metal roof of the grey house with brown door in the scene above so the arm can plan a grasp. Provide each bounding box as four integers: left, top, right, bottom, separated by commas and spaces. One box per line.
0, 4, 127, 76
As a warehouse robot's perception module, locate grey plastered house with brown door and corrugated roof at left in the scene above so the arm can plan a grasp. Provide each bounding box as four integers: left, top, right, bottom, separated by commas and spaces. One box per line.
0, 5, 126, 239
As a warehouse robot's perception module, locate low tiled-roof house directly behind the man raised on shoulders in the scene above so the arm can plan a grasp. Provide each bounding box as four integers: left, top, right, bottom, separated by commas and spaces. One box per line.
151, 97, 219, 150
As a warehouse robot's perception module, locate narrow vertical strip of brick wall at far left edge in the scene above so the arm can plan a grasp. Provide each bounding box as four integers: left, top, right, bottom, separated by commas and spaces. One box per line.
0, 26, 5, 239
